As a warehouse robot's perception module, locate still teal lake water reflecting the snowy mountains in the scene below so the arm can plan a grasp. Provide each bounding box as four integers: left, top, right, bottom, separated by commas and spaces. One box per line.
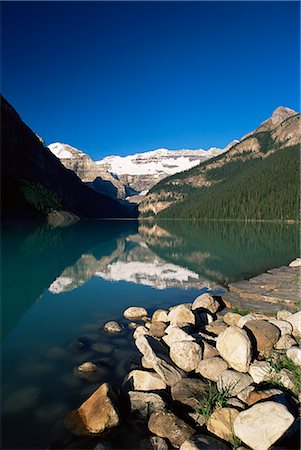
1, 221, 299, 449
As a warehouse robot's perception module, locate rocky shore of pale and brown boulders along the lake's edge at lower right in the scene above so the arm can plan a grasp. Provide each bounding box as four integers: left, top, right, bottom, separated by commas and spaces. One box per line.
66, 260, 301, 450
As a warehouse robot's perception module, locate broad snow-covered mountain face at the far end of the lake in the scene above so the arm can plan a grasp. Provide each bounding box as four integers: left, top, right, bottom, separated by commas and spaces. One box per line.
96, 143, 233, 192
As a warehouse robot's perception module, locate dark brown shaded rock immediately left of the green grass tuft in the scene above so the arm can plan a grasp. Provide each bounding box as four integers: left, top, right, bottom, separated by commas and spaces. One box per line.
171, 378, 209, 409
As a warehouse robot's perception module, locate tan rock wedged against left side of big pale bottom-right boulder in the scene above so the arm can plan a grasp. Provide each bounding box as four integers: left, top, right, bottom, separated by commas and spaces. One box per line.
207, 407, 239, 441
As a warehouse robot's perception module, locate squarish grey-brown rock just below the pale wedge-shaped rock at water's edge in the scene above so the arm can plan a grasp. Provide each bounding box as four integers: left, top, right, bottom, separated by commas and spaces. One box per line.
128, 391, 165, 419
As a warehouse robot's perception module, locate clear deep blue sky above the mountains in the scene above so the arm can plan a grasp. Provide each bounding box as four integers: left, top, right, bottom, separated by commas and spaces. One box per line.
1, 1, 300, 159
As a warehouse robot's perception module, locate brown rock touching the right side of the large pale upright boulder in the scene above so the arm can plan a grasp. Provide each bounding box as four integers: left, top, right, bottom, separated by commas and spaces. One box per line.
245, 320, 280, 354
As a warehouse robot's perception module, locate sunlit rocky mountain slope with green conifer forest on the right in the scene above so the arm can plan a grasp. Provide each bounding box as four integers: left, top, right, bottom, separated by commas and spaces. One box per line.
139, 107, 300, 219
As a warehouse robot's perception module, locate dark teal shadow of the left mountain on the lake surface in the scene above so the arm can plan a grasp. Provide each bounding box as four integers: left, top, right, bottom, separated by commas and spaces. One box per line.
1, 220, 137, 337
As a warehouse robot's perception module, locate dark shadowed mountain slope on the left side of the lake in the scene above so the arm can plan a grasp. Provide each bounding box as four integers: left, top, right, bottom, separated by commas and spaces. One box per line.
1, 98, 136, 220
